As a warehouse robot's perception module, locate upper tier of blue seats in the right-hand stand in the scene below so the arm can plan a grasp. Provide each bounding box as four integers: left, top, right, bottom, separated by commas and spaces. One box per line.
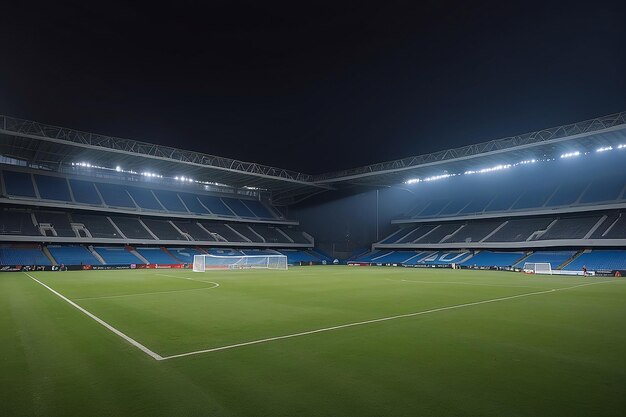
401, 153, 626, 219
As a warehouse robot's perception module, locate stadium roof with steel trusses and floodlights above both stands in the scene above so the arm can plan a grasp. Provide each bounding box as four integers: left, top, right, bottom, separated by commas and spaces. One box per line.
0, 112, 626, 204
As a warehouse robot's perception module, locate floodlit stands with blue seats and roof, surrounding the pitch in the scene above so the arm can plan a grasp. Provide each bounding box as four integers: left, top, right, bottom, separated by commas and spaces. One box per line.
0, 112, 626, 271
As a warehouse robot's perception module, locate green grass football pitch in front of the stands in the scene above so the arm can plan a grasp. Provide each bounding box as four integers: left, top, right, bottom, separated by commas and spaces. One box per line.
0, 266, 626, 417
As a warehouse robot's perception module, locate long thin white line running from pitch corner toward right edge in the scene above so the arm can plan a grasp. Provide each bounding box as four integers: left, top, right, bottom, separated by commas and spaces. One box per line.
162, 281, 615, 360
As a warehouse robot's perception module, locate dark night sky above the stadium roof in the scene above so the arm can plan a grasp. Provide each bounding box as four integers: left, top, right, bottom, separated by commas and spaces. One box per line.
0, 1, 626, 173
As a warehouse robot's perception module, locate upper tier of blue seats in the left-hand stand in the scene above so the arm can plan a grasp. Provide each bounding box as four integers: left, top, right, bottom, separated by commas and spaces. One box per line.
1, 169, 277, 220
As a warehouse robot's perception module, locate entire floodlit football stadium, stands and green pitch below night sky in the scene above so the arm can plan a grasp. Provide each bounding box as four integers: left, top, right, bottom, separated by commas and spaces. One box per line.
0, 113, 626, 416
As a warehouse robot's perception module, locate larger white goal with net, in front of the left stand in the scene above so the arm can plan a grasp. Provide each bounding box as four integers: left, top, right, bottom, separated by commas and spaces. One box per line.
193, 255, 287, 272
